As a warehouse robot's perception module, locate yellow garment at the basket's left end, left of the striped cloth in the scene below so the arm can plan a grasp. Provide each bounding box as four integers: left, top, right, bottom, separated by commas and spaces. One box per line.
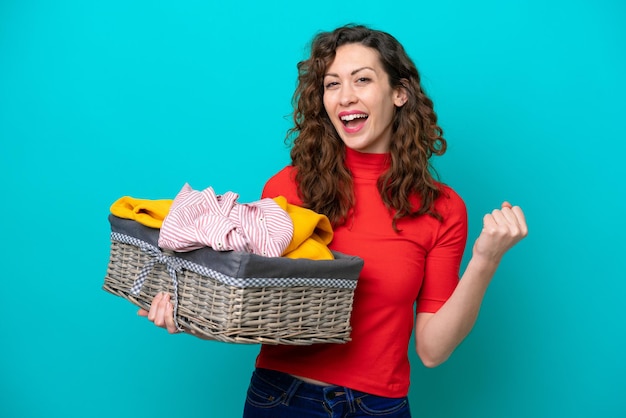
111, 196, 173, 228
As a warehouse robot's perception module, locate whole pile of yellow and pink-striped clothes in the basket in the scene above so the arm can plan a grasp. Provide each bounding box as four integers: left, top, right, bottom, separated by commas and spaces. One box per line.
111, 184, 333, 260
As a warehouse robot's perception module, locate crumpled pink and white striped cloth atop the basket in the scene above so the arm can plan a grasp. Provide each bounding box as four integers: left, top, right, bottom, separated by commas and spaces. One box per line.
159, 183, 293, 257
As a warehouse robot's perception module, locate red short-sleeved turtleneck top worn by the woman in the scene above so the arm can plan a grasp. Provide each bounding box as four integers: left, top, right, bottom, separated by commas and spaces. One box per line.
257, 148, 467, 398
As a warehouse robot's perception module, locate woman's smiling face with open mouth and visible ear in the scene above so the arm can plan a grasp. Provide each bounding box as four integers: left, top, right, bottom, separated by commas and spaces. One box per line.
324, 43, 407, 153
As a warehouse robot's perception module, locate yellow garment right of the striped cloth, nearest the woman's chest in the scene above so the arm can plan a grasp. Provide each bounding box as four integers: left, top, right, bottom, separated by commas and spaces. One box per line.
274, 196, 335, 260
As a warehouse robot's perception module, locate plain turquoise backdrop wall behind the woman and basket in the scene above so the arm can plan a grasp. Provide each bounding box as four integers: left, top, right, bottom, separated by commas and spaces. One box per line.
0, 0, 626, 418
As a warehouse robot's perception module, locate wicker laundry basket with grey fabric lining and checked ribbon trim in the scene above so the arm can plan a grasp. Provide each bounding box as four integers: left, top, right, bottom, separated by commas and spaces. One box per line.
103, 215, 363, 345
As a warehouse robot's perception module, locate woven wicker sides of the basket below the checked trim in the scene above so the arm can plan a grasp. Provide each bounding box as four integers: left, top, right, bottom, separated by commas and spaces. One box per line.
103, 241, 354, 345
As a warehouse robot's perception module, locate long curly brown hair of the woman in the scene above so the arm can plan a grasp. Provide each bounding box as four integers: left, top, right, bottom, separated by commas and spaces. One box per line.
287, 25, 446, 231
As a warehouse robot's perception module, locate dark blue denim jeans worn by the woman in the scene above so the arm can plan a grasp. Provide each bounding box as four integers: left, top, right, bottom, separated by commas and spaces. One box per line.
243, 369, 411, 418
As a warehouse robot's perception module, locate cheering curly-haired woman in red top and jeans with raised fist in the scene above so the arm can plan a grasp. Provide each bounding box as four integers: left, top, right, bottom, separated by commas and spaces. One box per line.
141, 25, 527, 417
